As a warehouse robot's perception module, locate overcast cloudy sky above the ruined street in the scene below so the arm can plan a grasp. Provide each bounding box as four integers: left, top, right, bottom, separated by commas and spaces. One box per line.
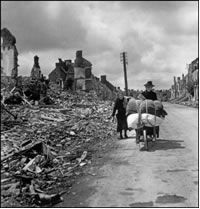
1, 1, 198, 89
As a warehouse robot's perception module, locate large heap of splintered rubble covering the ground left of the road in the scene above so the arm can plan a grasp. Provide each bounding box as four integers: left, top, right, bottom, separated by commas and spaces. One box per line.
1, 92, 115, 206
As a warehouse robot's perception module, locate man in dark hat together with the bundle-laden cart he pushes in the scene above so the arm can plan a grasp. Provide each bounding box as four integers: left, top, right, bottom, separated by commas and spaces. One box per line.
126, 81, 167, 150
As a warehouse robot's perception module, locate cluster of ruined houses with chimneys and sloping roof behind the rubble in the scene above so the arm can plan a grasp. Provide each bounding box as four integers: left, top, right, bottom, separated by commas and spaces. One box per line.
49, 51, 117, 100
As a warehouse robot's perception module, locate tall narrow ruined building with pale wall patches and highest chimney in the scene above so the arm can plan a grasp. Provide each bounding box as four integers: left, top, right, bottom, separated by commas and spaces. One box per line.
74, 50, 93, 91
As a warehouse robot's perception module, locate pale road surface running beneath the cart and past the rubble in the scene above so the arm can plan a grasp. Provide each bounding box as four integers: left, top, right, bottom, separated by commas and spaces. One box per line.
56, 103, 198, 207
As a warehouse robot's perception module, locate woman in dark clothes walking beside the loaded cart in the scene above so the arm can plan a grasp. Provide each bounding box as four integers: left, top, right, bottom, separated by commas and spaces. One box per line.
112, 92, 128, 139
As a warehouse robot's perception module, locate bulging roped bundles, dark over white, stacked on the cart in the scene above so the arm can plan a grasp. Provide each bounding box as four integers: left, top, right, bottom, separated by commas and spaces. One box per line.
126, 98, 167, 130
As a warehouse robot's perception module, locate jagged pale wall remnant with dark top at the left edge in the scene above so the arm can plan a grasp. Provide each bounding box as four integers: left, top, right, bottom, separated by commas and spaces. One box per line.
1, 28, 18, 78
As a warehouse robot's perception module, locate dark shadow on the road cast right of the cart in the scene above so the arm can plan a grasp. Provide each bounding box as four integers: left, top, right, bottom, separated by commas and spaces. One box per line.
149, 139, 185, 152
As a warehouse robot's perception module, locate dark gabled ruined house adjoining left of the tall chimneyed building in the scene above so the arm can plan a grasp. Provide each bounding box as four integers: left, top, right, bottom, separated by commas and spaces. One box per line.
49, 58, 74, 90
